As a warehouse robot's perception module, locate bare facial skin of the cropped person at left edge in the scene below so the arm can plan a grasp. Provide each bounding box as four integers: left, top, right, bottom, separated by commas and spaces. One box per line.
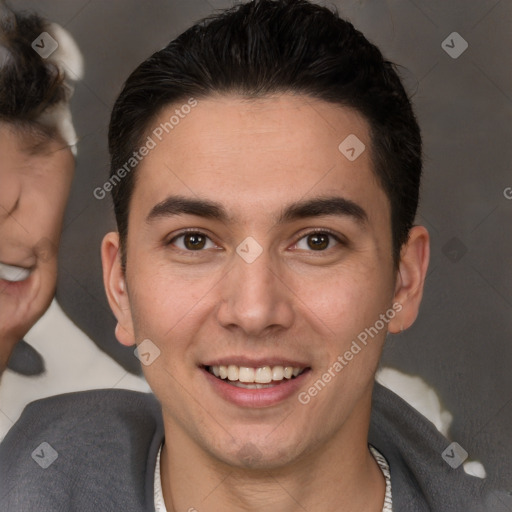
0, 123, 75, 374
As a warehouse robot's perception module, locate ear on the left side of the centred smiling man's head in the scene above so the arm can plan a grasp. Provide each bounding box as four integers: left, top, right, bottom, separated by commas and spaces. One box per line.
101, 233, 135, 346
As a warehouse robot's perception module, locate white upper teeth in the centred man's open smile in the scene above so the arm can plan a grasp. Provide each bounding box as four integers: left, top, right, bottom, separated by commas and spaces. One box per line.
204, 364, 309, 389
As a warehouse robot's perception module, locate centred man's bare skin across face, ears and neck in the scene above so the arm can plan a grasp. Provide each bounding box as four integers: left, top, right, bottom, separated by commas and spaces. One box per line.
102, 95, 429, 512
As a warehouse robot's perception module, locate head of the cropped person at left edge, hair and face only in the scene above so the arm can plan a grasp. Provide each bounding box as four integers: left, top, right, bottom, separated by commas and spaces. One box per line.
0, 3, 81, 374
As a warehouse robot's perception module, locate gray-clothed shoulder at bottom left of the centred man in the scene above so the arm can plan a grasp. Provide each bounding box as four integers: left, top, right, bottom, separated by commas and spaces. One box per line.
0, 389, 163, 511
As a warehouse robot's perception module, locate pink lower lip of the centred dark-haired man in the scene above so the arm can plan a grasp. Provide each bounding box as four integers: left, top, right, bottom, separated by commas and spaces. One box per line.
202, 368, 310, 408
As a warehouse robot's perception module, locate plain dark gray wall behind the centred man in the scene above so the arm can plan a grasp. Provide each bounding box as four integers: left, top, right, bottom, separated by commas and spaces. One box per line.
12, 0, 512, 491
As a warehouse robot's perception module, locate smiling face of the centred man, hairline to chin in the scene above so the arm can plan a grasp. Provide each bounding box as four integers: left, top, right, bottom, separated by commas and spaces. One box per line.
107, 95, 404, 467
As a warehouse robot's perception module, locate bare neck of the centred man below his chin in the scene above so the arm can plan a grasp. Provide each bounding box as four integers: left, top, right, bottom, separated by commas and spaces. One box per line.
161, 388, 385, 512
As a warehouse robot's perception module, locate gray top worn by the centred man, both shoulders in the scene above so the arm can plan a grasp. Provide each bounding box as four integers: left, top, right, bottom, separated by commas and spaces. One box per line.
0, 383, 494, 512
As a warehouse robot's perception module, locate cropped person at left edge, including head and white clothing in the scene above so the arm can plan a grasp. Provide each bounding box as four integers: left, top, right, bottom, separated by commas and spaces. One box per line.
0, 2, 147, 439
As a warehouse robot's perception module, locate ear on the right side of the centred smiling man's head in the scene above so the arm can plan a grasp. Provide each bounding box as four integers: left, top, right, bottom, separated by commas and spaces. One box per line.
388, 226, 430, 333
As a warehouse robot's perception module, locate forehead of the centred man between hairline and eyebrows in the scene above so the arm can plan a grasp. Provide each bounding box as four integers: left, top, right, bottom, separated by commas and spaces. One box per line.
134, 94, 386, 222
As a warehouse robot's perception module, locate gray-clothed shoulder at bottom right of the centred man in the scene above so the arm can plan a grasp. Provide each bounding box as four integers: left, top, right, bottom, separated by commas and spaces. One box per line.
369, 383, 484, 512
